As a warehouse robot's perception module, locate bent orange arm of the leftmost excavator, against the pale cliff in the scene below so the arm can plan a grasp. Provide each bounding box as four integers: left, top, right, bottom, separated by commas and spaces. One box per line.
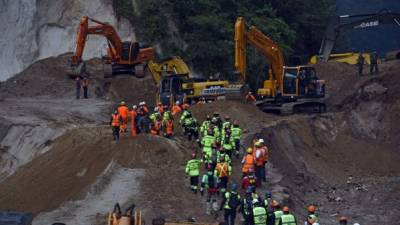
71, 16, 122, 65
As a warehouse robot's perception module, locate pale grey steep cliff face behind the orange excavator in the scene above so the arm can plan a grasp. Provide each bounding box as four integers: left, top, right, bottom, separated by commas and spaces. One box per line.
0, 0, 134, 80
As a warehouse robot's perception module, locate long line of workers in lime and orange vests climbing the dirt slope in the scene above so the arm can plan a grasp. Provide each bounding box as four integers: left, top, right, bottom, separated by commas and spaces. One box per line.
111, 99, 356, 225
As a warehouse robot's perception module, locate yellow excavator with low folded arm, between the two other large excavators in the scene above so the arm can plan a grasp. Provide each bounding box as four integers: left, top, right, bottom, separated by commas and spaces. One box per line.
147, 56, 240, 105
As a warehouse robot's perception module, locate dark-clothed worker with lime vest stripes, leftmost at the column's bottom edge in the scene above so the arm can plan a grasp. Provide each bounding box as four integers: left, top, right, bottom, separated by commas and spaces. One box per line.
220, 183, 241, 225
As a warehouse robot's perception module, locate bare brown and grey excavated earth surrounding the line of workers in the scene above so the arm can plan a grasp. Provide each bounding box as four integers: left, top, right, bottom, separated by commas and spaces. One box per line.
0, 55, 400, 225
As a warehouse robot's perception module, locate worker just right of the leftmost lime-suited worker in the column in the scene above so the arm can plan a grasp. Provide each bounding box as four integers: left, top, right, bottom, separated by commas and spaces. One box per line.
200, 166, 218, 215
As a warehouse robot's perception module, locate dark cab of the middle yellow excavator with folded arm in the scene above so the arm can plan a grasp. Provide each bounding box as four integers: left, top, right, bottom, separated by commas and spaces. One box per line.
159, 74, 185, 105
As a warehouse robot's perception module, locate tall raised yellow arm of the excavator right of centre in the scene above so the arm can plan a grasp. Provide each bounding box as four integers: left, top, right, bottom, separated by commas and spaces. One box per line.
235, 17, 285, 96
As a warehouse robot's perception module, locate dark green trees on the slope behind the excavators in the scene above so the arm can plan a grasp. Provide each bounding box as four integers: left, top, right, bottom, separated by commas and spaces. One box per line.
114, 0, 334, 87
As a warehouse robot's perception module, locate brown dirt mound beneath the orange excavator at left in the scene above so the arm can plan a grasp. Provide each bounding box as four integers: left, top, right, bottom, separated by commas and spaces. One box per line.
0, 54, 157, 105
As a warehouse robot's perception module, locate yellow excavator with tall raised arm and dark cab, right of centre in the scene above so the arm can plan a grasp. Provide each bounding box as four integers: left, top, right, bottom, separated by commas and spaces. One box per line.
235, 17, 326, 114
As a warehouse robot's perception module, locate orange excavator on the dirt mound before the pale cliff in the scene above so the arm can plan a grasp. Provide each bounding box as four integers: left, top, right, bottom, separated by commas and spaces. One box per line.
68, 16, 154, 77
